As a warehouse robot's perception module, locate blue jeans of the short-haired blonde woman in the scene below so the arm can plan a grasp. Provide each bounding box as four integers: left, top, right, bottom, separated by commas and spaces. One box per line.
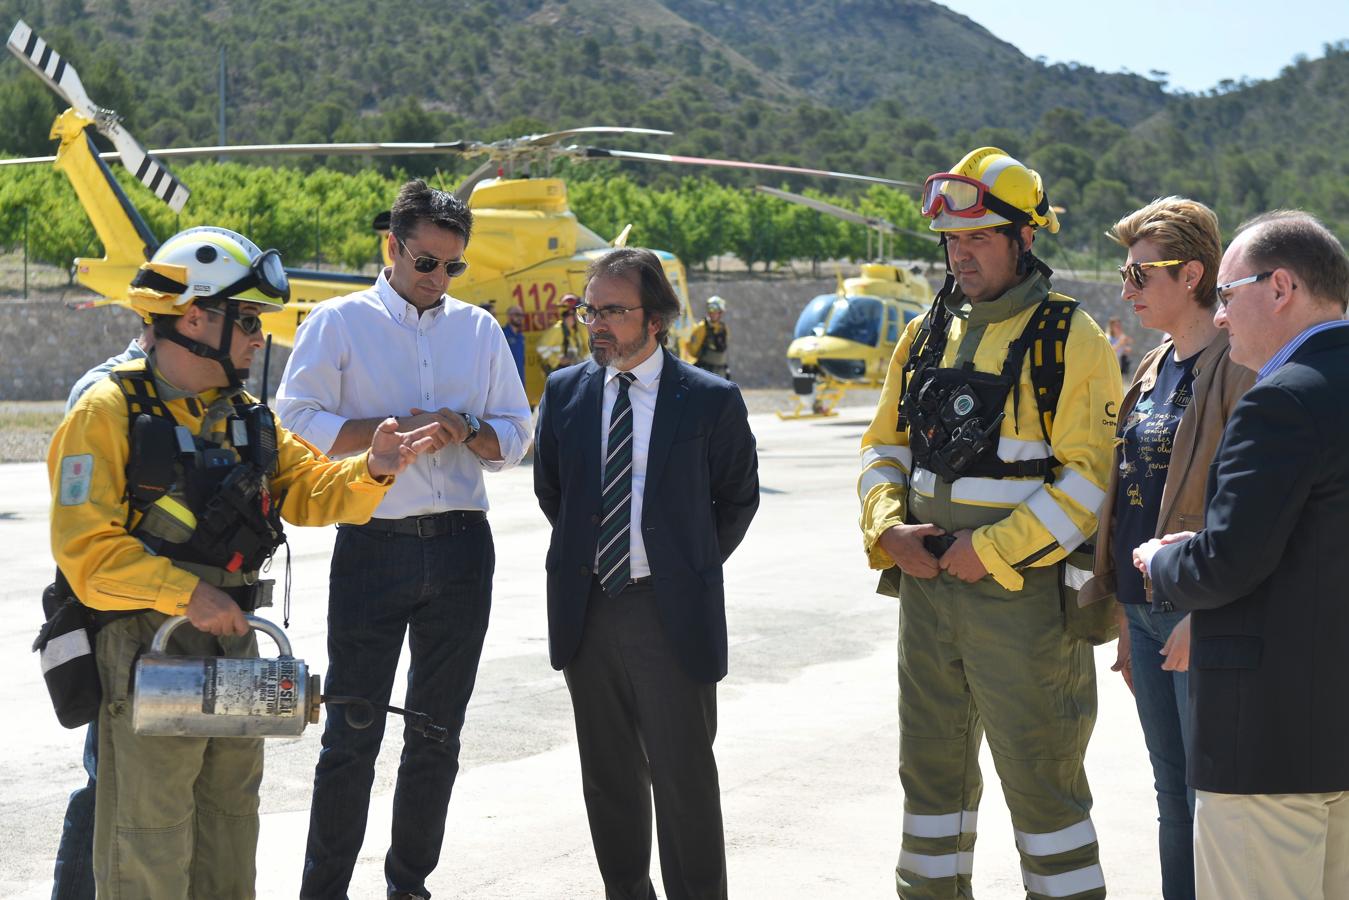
1124, 603, 1194, 900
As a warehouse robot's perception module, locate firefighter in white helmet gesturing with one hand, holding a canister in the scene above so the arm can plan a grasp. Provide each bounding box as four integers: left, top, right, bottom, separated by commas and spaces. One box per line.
47, 228, 444, 899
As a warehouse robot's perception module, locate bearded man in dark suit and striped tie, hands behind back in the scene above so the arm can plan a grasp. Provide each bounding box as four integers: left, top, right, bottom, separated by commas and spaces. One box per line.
534, 248, 758, 900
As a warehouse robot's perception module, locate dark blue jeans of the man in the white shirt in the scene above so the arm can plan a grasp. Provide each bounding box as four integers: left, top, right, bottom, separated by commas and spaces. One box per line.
299, 521, 496, 900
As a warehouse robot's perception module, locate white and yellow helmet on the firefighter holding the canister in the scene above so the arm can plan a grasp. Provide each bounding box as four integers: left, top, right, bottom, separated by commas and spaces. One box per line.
127, 225, 290, 321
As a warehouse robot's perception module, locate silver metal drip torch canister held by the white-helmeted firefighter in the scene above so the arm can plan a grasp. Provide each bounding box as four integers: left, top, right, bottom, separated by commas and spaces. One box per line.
132, 615, 322, 738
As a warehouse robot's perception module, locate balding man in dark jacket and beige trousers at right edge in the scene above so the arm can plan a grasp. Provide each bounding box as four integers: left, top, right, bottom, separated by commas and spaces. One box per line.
1135, 212, 1349, 900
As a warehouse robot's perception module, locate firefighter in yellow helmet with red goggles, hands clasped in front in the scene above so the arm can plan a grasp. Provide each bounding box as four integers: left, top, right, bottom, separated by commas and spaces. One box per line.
858, 147, 1121, 899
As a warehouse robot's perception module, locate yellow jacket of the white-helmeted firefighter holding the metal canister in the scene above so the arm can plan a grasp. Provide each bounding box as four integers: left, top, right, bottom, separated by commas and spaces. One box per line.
47, 360, 393, 615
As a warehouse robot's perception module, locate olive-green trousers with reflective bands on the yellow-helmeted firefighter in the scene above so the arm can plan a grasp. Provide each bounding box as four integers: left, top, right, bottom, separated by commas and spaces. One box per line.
882, 484, 1105, 900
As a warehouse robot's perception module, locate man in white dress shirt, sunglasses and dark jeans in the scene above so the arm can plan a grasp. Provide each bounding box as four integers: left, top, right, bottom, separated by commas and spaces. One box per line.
277, 181, 530, 899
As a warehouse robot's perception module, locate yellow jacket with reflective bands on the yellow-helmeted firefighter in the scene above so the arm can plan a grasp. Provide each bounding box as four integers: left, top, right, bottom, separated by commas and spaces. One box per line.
858, 273, 1122, 591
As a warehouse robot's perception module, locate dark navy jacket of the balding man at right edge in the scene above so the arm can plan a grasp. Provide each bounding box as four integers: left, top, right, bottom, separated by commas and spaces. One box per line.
1152, 328, 1349, 793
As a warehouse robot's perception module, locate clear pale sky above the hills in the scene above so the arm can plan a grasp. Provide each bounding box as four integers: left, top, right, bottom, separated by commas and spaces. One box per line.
938, 0, 1349, 92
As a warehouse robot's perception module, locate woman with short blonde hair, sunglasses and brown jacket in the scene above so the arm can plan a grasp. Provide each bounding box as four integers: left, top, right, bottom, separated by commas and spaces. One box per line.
1082, 197, 1255, 900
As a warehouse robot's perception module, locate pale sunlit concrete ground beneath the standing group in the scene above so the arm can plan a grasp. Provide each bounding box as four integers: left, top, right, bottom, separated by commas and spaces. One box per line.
0, 409, 1161, 900
